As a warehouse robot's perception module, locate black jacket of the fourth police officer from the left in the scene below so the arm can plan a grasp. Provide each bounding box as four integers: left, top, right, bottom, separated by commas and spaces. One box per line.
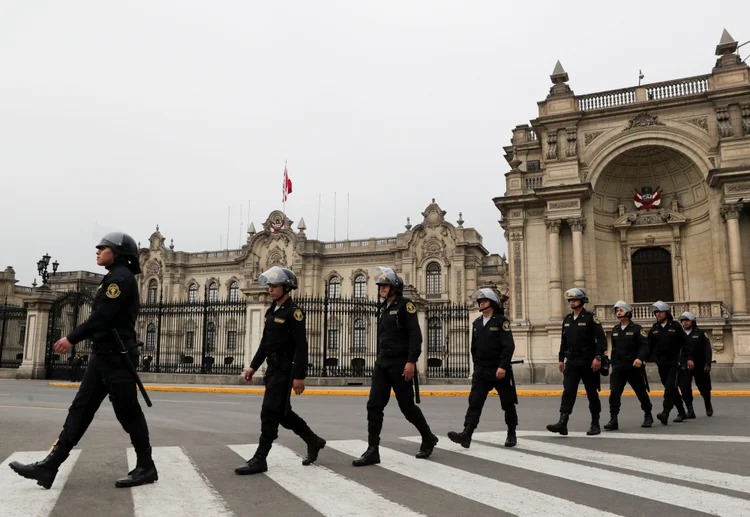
471, 314, 516, 371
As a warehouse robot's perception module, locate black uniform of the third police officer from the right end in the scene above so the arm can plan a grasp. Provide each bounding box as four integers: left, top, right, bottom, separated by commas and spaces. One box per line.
609, 321, 652, 416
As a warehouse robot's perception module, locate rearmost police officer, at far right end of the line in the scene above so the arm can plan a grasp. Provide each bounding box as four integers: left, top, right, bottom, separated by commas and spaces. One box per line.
680, 312, 714, 418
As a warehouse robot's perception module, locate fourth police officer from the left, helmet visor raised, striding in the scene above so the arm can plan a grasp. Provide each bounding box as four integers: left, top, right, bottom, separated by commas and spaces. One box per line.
448, 287, 518, 448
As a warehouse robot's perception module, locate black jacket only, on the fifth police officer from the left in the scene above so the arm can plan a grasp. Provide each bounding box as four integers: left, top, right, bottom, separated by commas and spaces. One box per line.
558, 309, 607, 362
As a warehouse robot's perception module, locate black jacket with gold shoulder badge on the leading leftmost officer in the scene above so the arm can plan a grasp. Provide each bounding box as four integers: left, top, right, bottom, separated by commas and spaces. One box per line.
67, 264, 141, 346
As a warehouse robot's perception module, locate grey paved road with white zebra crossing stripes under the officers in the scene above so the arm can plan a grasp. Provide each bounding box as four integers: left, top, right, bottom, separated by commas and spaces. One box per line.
0, 381, 750, 517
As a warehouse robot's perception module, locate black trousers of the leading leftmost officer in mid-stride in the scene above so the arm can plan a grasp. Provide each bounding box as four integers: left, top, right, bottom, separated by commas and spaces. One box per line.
58, 351, 151, 466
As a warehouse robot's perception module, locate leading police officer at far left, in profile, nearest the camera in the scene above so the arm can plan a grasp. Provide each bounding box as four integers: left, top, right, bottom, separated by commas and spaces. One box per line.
10, 232, 159, 488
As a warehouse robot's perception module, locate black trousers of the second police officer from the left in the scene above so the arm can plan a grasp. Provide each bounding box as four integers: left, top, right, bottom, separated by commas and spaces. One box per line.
260, 365, 313, 446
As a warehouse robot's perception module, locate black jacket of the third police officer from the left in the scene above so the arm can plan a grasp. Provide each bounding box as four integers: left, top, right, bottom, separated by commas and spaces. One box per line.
378, 296, 422, 363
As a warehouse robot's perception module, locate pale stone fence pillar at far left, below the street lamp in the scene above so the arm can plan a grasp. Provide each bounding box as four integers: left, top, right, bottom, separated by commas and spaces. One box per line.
16, 287, 59, 379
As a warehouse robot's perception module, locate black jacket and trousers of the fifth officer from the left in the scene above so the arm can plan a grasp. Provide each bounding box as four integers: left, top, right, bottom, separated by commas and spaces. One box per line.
558, 309, 607, 418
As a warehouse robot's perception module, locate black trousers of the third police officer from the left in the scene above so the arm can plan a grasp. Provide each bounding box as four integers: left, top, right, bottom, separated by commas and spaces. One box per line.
367, 357, 432, 446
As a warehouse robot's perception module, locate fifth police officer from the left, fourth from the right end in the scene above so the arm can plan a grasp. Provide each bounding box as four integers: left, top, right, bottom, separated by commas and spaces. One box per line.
547, 288, 607, 436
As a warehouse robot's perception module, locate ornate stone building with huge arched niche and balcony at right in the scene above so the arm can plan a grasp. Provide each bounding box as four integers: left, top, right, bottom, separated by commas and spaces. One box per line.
494, 31, 750, 382
